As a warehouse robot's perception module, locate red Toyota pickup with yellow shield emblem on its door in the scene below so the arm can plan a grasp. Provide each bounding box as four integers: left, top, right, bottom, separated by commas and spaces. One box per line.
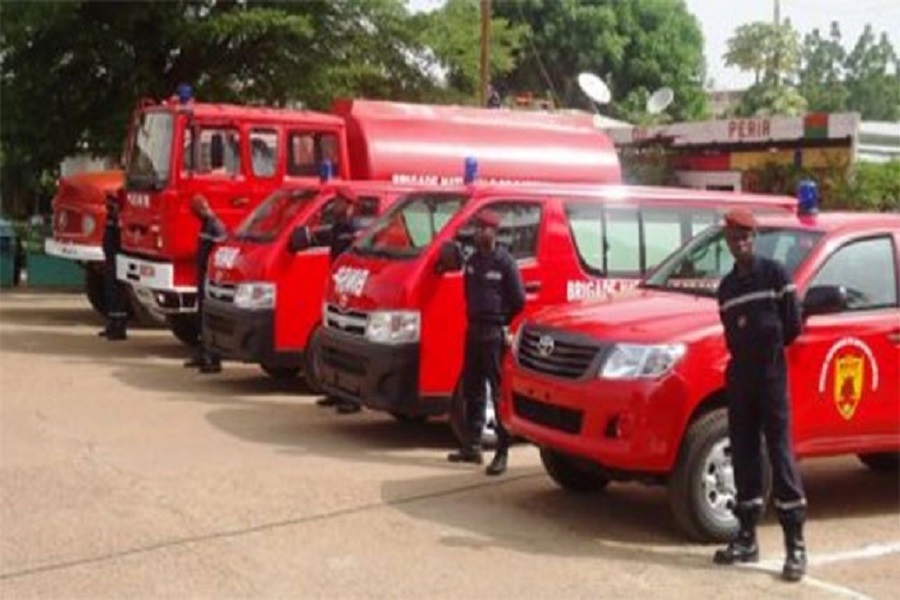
501, 202, 900, 541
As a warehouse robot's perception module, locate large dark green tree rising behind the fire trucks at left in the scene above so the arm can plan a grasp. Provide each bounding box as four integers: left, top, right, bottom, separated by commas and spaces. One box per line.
0, 0, 434, 216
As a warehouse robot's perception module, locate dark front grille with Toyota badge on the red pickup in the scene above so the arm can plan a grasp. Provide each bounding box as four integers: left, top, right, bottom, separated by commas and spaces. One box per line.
518, 326, 604, 379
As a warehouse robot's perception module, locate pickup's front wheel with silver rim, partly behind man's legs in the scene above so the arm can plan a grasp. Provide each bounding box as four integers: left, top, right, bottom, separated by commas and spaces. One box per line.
668, 408, 772, 542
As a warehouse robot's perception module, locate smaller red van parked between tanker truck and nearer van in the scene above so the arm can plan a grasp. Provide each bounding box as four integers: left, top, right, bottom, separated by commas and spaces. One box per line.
202, 181, 426, 384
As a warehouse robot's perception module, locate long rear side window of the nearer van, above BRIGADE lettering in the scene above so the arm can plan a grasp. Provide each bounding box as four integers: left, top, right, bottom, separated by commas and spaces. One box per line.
566, 201, 716, 277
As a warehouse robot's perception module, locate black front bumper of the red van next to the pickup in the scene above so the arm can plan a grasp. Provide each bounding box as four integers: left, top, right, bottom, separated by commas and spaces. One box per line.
319, 328, 449, 417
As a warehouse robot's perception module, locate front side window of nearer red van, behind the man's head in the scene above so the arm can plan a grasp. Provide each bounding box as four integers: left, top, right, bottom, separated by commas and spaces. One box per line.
456, 201, 541, 260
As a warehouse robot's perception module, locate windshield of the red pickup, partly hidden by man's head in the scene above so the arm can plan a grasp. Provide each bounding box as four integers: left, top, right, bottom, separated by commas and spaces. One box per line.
641, 226, 822, 297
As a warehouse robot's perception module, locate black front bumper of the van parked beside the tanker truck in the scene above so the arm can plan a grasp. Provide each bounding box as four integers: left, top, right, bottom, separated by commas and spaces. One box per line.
203, 298, 303, 368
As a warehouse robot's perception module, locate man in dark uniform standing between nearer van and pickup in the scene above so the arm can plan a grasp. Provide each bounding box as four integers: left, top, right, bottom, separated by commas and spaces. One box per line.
447, 210, 525, 475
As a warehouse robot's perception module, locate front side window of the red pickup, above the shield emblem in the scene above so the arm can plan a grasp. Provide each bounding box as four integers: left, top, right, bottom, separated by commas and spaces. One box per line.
810, 236, 897, 310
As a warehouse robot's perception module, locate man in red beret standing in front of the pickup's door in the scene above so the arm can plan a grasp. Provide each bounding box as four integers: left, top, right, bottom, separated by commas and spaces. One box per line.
714, 209, 806, 581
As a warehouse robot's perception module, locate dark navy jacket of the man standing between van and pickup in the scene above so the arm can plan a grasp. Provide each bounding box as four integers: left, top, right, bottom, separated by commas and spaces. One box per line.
464, 246, 525, 326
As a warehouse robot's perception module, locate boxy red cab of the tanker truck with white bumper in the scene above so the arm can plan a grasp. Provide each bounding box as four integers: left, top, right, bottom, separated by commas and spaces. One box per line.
116, 97, 349, 343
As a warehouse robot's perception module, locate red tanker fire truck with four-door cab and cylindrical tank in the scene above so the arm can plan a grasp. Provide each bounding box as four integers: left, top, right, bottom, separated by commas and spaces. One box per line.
117, 100, 620, 341
